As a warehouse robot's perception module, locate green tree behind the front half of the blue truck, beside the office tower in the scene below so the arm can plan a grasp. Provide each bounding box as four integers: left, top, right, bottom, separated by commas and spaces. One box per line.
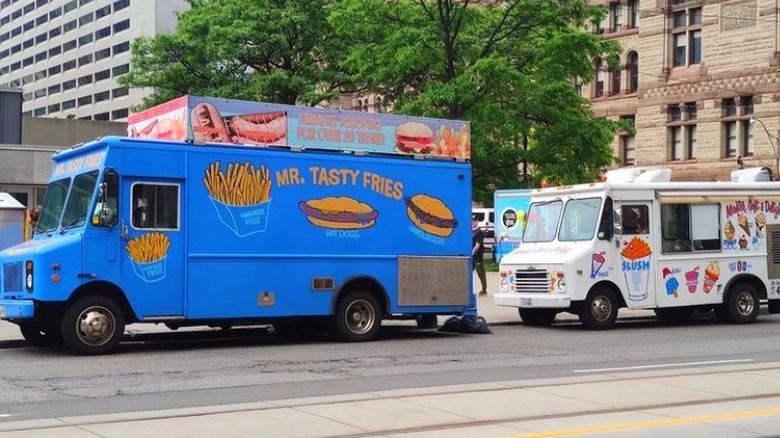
120, 0, 349, 108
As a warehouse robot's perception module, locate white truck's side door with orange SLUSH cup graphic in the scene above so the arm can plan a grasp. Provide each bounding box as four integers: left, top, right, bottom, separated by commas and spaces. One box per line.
618, 201, 660, 308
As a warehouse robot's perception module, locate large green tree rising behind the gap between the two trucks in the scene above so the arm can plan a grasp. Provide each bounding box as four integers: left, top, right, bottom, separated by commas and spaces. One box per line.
329, 0, 620, 202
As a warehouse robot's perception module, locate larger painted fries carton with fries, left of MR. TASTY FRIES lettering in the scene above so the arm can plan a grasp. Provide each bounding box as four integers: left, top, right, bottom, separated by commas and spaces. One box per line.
203, 161, 271, 237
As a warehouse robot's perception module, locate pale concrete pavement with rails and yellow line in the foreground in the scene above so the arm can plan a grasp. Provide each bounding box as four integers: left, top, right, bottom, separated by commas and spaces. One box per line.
0, 363, 780, 438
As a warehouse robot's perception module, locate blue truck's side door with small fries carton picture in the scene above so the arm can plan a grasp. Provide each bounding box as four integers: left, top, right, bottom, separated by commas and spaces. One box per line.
120, 179, 185, 319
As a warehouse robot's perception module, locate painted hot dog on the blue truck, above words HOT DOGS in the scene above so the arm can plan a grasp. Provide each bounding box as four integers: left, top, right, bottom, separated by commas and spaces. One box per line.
298, 196, 379, 230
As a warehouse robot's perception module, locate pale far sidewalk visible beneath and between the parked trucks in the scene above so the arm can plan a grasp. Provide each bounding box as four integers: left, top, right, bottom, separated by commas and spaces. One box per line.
0, 272, 655, 341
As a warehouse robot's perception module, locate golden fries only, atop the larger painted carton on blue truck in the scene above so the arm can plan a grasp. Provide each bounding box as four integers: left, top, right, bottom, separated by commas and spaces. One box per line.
203, 161, 271, 206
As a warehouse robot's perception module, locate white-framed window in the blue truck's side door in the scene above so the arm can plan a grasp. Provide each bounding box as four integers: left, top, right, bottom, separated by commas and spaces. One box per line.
132, 184, 179, 230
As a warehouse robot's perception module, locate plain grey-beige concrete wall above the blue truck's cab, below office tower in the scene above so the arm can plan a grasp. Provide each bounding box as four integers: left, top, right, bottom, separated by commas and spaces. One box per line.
22, 117, 127, 147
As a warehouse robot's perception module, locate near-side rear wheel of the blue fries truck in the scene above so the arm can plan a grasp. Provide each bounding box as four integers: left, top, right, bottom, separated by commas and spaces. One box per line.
333, 291, 382, 342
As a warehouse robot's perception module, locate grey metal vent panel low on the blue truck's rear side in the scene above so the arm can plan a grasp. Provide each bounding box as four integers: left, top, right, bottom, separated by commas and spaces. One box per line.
398, 257, 471, 306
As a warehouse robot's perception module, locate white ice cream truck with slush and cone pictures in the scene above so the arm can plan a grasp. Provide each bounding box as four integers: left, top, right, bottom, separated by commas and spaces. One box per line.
494, 168, 780, 329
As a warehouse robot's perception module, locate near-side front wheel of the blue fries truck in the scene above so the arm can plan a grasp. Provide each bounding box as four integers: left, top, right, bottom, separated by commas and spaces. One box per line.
61, 295, 125, 355
